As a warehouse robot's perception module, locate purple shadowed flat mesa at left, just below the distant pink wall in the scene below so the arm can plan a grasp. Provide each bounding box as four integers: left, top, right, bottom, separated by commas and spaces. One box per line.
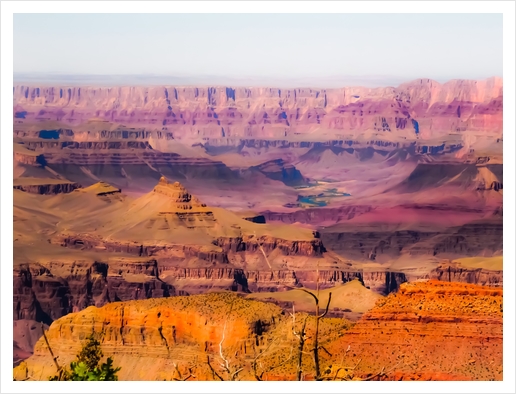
15, 139, 239, 184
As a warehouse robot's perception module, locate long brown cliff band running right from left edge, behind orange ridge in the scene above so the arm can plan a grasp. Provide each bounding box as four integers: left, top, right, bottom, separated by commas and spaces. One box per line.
13, 252, 406, 324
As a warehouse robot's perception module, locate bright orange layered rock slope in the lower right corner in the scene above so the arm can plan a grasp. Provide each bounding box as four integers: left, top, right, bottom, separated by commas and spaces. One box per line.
328, 281, 503, 380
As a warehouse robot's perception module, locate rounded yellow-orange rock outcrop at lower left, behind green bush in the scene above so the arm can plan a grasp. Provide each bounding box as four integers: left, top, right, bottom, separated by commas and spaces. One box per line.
14, 293, 284, 380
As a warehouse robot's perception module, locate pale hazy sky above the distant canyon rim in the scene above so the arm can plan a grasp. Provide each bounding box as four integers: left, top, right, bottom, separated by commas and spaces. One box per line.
14, 14, 502, 85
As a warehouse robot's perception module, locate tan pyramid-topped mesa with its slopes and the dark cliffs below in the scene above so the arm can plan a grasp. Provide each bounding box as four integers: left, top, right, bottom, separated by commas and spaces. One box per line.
13, 177, 406, 330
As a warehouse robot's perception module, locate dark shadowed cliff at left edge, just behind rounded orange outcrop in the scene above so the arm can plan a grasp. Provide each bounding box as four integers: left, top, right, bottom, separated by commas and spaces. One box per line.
13, 258, 176, 324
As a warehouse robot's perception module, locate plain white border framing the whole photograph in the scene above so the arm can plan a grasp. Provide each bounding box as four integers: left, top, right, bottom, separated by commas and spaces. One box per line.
0, 1, 516, 393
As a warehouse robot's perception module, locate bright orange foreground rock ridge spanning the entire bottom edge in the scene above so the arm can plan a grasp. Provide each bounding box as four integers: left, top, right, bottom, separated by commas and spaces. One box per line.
14, 281, 503, 380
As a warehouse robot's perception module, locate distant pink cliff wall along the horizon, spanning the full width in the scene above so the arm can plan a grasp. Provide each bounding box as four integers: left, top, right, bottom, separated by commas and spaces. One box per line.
13, 78, 503, 138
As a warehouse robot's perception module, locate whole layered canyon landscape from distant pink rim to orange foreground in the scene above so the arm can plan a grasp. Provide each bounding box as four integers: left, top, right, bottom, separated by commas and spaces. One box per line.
13, 78, 503, 380
